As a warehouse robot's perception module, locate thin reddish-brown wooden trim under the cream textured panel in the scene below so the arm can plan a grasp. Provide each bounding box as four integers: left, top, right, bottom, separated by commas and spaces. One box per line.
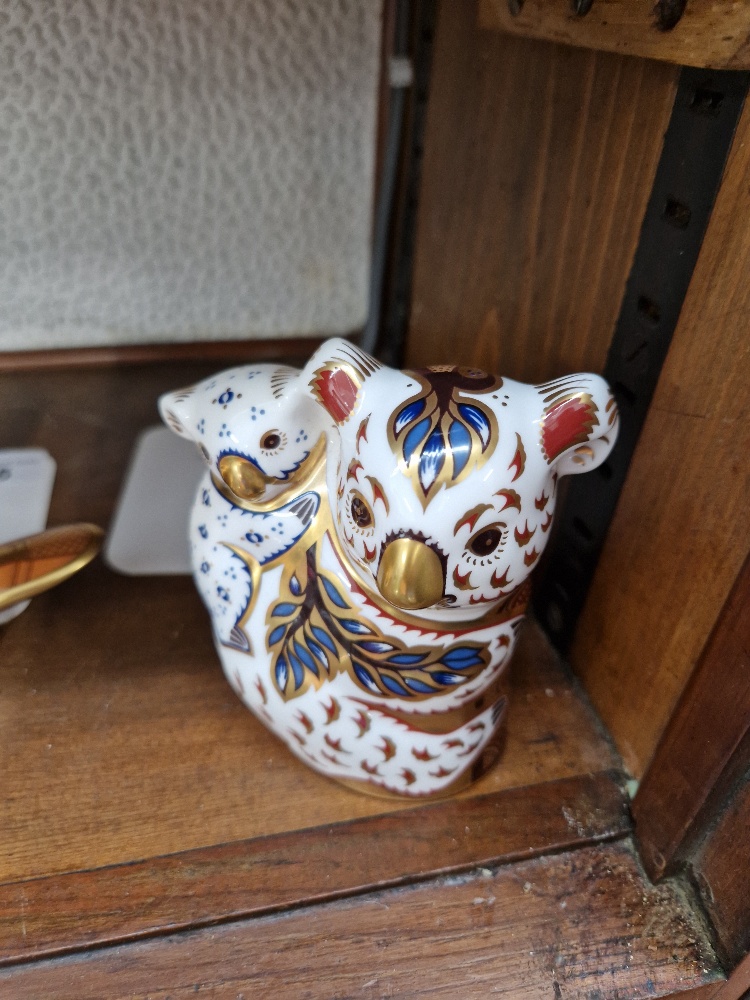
0, 337, 332, 373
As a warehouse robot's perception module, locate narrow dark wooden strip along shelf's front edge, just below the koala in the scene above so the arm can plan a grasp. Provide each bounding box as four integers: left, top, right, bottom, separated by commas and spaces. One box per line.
0, 772, 631, 966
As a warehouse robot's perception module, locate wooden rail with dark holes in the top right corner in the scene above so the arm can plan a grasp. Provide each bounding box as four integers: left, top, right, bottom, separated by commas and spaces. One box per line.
480, 0, 750, 69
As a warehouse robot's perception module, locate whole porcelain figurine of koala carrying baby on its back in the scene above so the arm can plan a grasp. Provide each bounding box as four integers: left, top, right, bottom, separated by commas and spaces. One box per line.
159, 339, 618, 797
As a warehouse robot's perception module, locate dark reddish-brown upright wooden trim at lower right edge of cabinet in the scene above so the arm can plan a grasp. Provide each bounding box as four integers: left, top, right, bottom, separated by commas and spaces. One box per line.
633, 559, 750, 876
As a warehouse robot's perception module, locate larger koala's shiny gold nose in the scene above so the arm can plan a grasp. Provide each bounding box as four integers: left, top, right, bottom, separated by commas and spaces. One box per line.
378, 538, 443, 611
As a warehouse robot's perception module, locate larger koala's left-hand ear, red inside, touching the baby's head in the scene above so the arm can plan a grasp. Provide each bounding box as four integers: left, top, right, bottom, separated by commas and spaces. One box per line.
300, 337, 383, 424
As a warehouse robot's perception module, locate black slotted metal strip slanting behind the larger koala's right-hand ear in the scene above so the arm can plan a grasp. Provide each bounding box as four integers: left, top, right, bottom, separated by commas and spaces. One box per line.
534, 68, 750, 650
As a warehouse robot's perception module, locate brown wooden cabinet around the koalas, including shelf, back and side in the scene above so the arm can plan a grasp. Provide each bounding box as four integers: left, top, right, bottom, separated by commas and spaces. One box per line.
0, 0, 750, 1000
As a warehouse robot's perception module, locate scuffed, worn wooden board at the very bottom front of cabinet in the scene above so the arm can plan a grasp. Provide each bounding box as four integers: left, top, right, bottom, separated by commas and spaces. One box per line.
0, 844, 721, 1000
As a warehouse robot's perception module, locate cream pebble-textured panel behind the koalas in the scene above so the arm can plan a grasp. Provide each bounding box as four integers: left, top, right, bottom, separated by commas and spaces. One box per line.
0, 0, 381, 350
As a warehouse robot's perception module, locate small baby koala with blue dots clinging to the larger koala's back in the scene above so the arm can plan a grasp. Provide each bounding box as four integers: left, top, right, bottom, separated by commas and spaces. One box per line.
159, 364, 325, 653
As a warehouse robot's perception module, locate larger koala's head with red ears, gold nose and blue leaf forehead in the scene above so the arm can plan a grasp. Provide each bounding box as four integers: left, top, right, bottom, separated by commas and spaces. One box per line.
313, 344, 618, 622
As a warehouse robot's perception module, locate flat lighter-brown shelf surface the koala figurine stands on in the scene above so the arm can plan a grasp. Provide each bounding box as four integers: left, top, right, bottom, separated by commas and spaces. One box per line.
0, 565, 617, 880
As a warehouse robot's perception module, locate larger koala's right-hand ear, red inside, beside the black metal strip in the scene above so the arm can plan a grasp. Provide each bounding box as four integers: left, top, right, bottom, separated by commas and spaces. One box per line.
536, 374, 619, 476
